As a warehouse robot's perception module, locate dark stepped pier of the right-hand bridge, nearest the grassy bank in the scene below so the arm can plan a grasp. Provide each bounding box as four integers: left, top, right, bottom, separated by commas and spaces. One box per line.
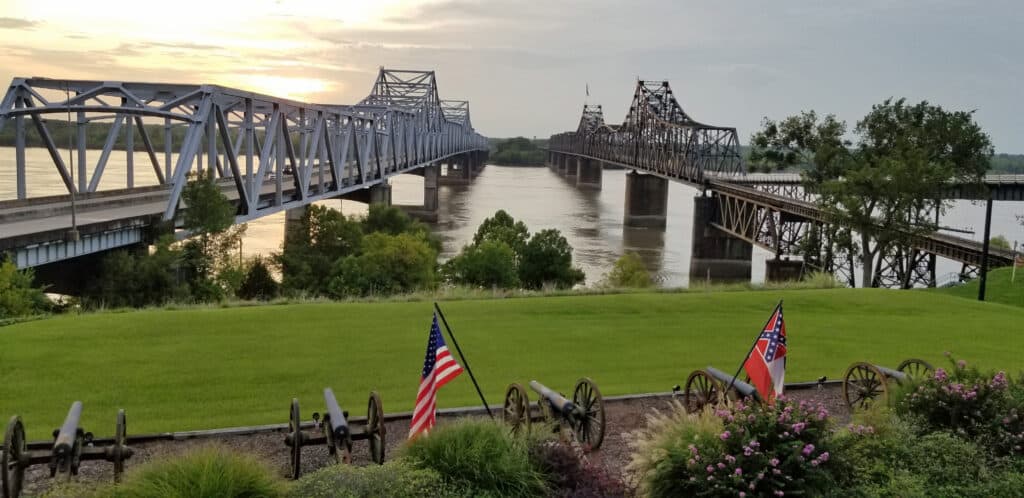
690, 196, 754, 285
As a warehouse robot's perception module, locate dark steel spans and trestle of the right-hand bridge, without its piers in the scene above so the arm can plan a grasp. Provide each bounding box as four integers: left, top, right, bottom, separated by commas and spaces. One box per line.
549, 80, 1024, 288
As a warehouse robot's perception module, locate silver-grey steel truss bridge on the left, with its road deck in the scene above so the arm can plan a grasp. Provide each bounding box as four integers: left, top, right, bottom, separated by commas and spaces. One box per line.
0, 68, 487, 267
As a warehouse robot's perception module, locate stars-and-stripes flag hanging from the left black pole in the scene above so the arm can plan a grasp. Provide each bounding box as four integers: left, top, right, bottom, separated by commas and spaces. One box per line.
409, 314, 462, 439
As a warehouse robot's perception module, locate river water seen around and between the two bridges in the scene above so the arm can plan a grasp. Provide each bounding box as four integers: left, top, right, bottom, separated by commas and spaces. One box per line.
0, 148, 1024, 287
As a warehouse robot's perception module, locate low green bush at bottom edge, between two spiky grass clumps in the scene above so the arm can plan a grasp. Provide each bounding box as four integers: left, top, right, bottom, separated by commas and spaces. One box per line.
288, 459, 456, 498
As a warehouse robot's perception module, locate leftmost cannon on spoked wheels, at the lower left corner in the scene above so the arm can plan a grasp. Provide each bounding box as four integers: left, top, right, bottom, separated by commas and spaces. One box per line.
0, 402, 133, 498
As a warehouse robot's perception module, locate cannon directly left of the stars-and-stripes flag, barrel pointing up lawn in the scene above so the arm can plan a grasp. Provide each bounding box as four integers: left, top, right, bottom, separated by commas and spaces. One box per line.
285, 387, 386, 479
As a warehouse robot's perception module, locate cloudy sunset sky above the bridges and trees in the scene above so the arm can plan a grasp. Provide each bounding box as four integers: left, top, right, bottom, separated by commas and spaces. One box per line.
0, 0, 1024, 153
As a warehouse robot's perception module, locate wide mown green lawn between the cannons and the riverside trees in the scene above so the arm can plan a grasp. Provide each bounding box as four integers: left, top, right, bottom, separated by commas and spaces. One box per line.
0, 289, 1024, 439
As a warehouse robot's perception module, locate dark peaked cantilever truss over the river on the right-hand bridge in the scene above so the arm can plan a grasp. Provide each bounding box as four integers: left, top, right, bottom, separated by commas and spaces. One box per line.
549, 80, 743, 184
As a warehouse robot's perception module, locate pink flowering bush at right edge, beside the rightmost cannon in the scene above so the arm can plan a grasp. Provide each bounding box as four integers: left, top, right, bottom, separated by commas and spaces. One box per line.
895, 359, 1024, 456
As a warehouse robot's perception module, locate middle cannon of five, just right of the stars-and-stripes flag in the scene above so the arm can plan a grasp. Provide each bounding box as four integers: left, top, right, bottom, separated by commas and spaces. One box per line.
504, 378, 604, 450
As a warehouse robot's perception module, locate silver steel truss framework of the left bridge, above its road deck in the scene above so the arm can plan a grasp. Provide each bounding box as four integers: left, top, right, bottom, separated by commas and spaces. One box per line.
0, 68, 487, 222
